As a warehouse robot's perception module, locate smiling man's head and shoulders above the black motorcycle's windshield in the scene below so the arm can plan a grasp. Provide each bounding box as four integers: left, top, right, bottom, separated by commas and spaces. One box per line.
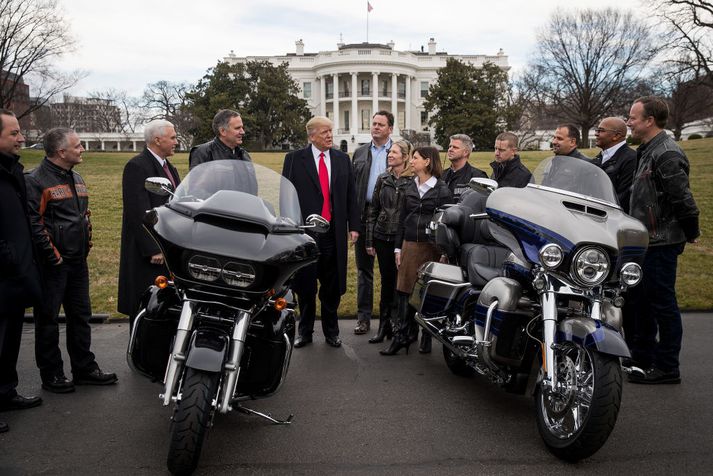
188, 109, 252, 169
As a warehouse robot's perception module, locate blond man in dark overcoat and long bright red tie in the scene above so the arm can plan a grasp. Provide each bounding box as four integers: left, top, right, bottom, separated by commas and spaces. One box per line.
282, 116, 361, 348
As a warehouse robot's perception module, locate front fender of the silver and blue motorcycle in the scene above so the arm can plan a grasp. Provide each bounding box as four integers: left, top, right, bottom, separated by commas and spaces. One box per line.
555, 317, 631, 358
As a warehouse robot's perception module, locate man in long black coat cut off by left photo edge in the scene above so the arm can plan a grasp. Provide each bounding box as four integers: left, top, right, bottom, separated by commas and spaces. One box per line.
0, 109, 42, 433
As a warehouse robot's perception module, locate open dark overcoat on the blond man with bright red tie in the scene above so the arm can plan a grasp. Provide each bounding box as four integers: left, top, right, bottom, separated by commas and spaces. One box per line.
282, 145, 361, 294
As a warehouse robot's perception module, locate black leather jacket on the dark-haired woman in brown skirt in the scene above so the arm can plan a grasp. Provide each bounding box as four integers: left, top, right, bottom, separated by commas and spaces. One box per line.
394, 178, 453, 248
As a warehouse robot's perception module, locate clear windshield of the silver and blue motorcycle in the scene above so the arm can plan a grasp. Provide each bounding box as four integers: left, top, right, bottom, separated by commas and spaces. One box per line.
528, 155, 619, 206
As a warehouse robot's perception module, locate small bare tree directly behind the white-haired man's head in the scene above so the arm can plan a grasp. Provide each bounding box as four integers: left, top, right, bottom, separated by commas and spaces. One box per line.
140, 81, 195, 148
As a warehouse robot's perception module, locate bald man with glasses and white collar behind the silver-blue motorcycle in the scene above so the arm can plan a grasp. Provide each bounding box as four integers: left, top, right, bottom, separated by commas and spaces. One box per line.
593, 117, 636, 213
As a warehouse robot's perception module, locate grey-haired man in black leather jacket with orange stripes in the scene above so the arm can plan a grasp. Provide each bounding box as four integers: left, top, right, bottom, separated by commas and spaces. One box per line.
25, 128, 117, 393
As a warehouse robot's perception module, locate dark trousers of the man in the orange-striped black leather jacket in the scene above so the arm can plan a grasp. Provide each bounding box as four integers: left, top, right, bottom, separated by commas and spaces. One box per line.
34, 260, 98, 379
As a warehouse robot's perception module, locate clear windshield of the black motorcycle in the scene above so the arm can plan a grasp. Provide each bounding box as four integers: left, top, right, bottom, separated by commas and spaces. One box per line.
168, 160, 302, 229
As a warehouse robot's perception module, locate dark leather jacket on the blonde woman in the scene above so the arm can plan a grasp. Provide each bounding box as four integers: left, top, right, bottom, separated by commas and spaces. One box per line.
365, 171, 413, 248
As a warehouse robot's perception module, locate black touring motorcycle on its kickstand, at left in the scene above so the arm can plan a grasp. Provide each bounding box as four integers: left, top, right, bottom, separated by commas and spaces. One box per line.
127, 160, 329, 474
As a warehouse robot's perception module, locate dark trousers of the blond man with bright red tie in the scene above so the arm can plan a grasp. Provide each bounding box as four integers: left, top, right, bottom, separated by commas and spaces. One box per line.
294, 229, 342, 337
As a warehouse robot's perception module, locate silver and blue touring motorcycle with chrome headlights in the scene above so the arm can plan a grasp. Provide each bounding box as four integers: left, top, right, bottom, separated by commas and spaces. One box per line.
410, 156, 648, 461
